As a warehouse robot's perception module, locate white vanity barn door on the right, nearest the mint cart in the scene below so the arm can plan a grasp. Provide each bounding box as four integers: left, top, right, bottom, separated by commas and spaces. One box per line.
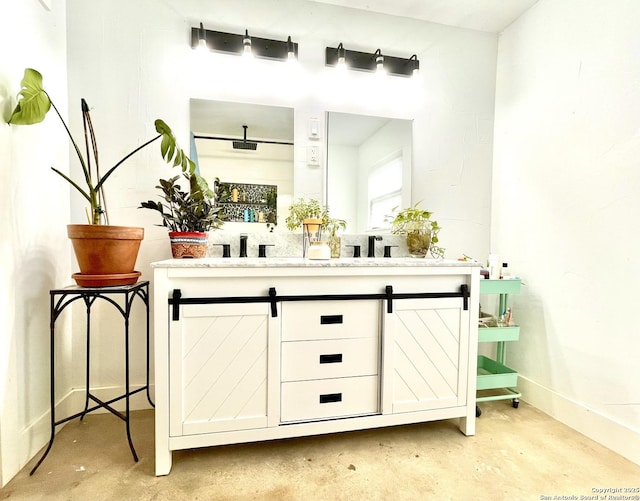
383, 298, 469, 413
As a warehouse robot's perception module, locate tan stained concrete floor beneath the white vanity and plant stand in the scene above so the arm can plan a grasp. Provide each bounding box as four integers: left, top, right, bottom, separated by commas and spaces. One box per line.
0, 401, 640, 501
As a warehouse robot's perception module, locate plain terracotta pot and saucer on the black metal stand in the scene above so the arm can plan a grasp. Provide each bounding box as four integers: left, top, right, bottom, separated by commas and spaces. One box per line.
67, 224, 144, 280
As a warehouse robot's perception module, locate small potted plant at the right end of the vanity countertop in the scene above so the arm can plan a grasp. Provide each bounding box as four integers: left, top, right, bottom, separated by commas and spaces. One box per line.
385, 202, 444, 258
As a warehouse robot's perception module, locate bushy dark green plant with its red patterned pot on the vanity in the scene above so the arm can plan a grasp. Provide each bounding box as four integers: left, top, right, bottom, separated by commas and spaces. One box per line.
139, 173, 224, 258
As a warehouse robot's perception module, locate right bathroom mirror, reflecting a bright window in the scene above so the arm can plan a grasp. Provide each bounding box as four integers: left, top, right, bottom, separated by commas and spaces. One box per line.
326, 111, 412, 233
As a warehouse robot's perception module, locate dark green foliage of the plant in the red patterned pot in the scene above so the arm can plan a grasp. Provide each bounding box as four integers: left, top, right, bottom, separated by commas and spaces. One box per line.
139, 173, 224, 231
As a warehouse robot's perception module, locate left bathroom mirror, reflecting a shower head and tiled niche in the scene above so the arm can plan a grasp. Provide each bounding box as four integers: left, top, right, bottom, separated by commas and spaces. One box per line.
190, 99, 294, 228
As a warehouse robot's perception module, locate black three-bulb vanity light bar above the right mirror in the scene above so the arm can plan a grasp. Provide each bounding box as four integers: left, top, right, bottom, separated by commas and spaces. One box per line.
325, 43, 420, 77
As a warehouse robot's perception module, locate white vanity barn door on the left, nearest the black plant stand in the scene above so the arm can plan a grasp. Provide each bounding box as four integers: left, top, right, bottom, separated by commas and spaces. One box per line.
169, 303, 270, 436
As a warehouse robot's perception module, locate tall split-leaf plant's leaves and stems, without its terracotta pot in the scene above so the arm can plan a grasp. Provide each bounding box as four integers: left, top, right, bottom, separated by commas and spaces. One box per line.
9, 68, 202, 224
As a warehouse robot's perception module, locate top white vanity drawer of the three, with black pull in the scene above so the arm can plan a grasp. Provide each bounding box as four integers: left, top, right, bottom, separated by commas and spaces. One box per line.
282, 300, 380, 341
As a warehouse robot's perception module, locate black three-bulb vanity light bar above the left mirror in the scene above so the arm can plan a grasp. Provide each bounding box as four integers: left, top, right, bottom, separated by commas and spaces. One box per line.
191, 23, 298, 61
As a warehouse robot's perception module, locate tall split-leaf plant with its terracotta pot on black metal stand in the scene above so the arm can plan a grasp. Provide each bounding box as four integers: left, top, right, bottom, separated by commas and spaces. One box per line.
8, 68, 198, 286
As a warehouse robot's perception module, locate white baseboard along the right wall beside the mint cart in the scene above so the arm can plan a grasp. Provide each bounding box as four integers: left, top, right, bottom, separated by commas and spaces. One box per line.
518, 376, 640, 465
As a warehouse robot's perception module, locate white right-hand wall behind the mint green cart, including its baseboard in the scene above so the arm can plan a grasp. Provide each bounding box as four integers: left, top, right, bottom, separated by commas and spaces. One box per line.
492, 0, 640, 463
